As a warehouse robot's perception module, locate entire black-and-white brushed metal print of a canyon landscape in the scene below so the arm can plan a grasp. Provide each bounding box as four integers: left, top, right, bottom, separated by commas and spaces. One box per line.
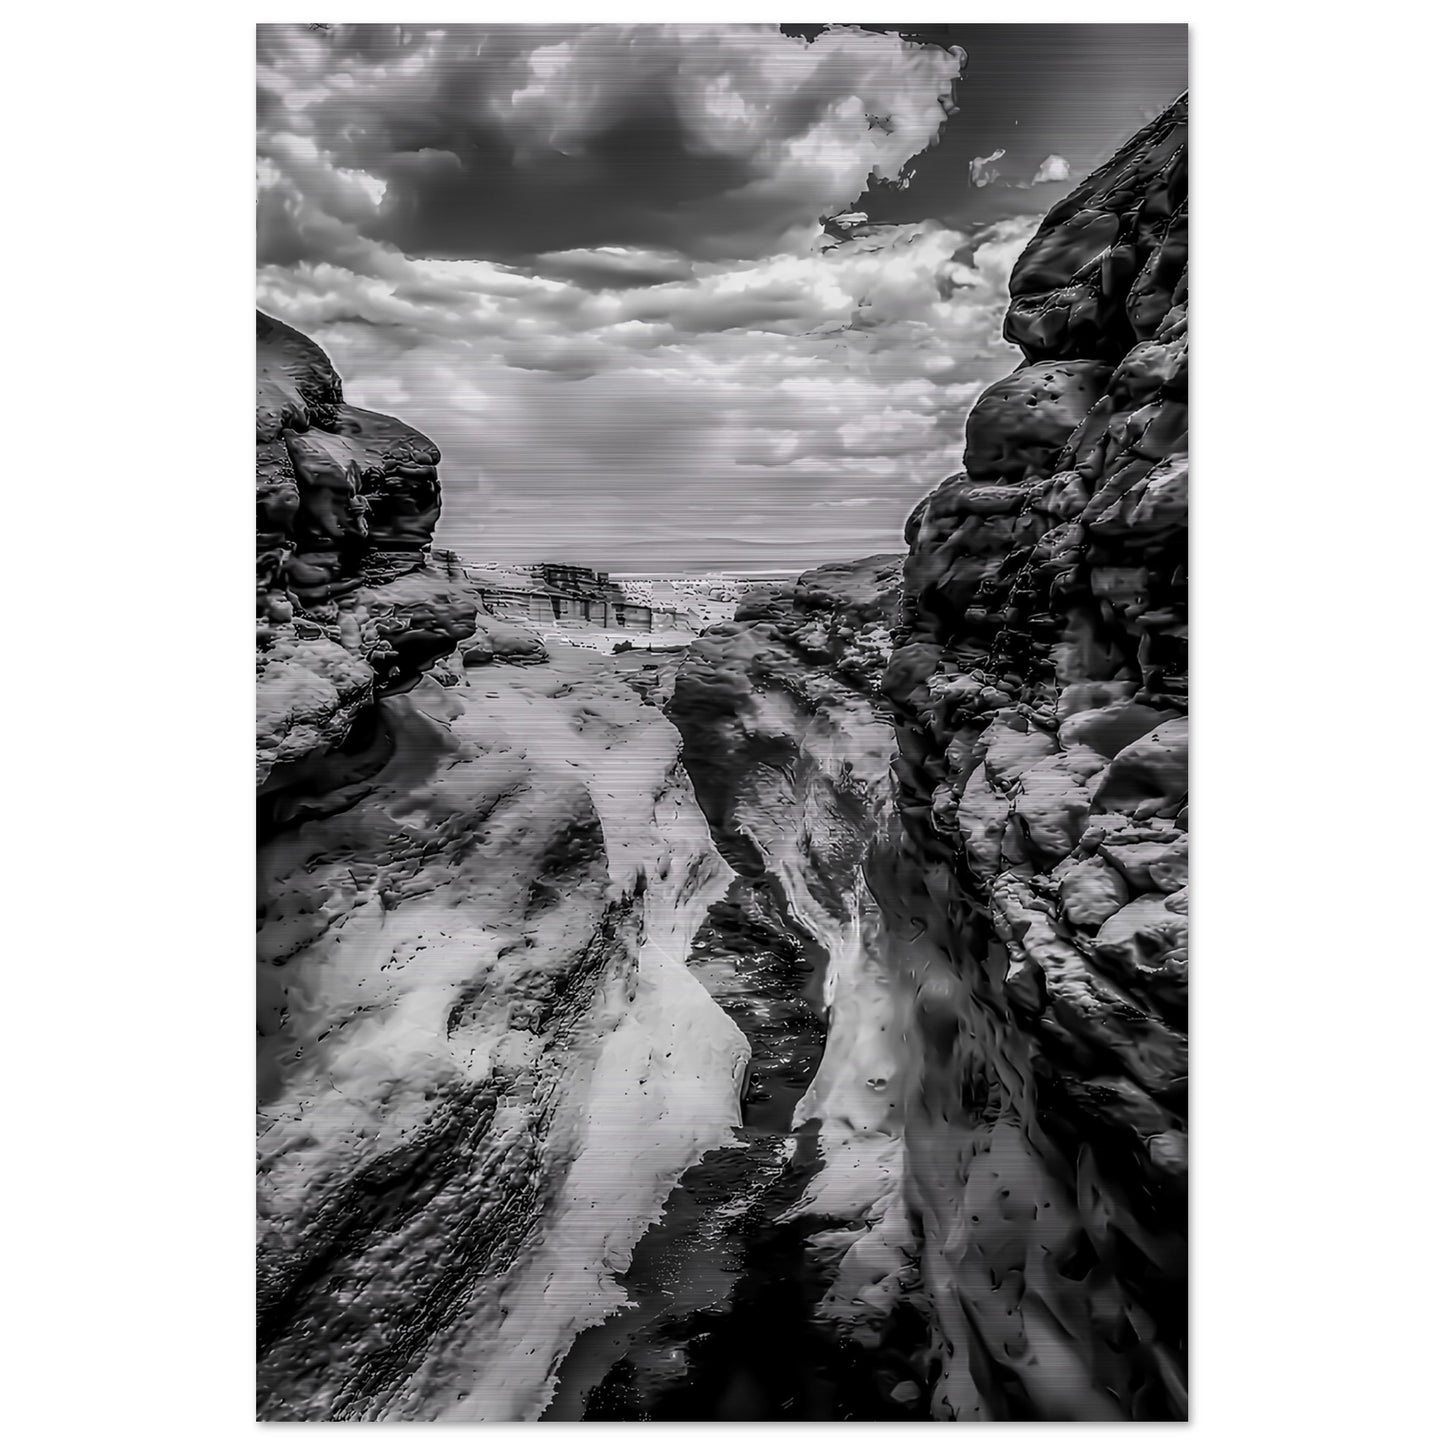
256, 25, 1189, 1422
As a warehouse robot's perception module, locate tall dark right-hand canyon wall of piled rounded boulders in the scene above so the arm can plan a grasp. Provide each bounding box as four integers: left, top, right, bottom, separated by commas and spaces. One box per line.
868, 100, 1188, 1419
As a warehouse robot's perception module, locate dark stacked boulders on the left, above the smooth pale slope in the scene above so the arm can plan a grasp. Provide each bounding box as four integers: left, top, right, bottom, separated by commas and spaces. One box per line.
256, 312, 478, 785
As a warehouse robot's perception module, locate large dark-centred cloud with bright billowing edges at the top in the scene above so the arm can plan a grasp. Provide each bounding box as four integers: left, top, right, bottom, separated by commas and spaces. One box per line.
257, 26, 962, 264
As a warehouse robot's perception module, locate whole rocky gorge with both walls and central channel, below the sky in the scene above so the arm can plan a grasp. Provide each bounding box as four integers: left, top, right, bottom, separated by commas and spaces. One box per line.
256, 90, 1188, 1422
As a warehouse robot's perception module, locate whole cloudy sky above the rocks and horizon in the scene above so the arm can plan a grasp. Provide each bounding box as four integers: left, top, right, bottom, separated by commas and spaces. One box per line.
257, 25, 1186, 571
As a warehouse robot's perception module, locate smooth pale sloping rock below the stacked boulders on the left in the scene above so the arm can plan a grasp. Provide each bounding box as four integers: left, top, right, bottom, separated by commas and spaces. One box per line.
257, 649, 747, 1420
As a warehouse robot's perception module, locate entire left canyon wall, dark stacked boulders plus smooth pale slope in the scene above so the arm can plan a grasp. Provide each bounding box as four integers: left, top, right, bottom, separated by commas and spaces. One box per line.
257, 318, 747, 1420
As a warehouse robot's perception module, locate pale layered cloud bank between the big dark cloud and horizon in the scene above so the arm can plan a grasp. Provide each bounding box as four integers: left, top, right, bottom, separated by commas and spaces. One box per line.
260, 217, 1038, 568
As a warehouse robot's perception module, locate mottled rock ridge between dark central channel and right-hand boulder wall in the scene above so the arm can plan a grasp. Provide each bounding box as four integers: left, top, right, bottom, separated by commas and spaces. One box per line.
668, 555, 915, 1352
